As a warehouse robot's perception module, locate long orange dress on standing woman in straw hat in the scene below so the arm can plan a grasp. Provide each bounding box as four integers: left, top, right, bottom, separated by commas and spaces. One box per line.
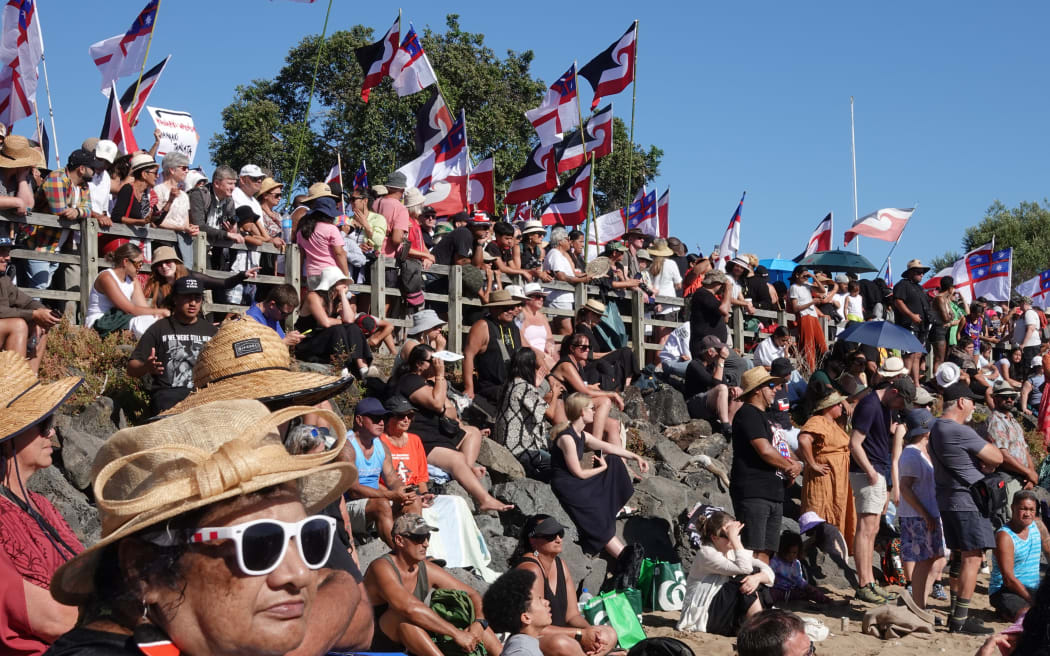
801, 415, 857, 544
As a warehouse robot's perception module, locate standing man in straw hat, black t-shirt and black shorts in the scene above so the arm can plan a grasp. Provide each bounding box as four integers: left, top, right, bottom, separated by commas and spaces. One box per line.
729, 366, 802, 563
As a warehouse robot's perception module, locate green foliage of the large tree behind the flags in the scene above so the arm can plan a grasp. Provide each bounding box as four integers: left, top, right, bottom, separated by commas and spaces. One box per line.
209, 14, 663, 211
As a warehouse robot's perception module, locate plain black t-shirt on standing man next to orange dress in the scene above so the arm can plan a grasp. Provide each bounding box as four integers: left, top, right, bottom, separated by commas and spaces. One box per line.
729, 403, 784, 502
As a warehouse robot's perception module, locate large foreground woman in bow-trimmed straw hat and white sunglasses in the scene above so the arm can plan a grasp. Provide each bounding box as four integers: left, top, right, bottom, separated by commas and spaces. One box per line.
51, 400, 357, 656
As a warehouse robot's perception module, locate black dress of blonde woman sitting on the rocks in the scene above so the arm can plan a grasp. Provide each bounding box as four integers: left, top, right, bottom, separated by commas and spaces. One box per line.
550, 426, 634, 553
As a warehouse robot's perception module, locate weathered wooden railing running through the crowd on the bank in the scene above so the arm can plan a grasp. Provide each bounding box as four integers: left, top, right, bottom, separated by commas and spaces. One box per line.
0, 212, 832, 367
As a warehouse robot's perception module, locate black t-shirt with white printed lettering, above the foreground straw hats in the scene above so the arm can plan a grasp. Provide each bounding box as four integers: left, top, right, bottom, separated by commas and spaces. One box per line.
131, 317, 219, 411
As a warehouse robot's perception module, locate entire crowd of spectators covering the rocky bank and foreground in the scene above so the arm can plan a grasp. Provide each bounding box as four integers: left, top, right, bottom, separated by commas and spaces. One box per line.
0, 135, 1050, 656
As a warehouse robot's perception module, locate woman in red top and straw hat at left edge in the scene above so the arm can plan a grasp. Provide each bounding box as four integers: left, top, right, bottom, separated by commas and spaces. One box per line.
0, 351, 83, 654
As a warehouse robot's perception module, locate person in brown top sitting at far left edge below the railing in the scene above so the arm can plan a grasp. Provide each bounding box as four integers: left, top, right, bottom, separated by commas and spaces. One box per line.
0, 237, 59, 371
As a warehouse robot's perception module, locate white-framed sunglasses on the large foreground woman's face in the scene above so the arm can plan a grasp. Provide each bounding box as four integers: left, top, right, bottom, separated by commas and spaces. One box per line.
190, 514, 335, 576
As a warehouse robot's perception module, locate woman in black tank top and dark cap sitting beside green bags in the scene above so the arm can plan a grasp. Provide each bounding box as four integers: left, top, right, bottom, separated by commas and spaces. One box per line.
512, 513, 617, 656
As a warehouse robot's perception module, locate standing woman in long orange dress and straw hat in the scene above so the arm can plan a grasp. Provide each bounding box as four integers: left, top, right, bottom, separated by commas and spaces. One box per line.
798, 392, 857, 554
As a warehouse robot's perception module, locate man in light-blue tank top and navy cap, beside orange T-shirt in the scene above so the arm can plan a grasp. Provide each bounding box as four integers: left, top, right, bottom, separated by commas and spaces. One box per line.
347, 398, 417, 547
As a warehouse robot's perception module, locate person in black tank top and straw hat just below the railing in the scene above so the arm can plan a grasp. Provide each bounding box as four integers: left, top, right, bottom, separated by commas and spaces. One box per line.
463, 290, 522, 406
